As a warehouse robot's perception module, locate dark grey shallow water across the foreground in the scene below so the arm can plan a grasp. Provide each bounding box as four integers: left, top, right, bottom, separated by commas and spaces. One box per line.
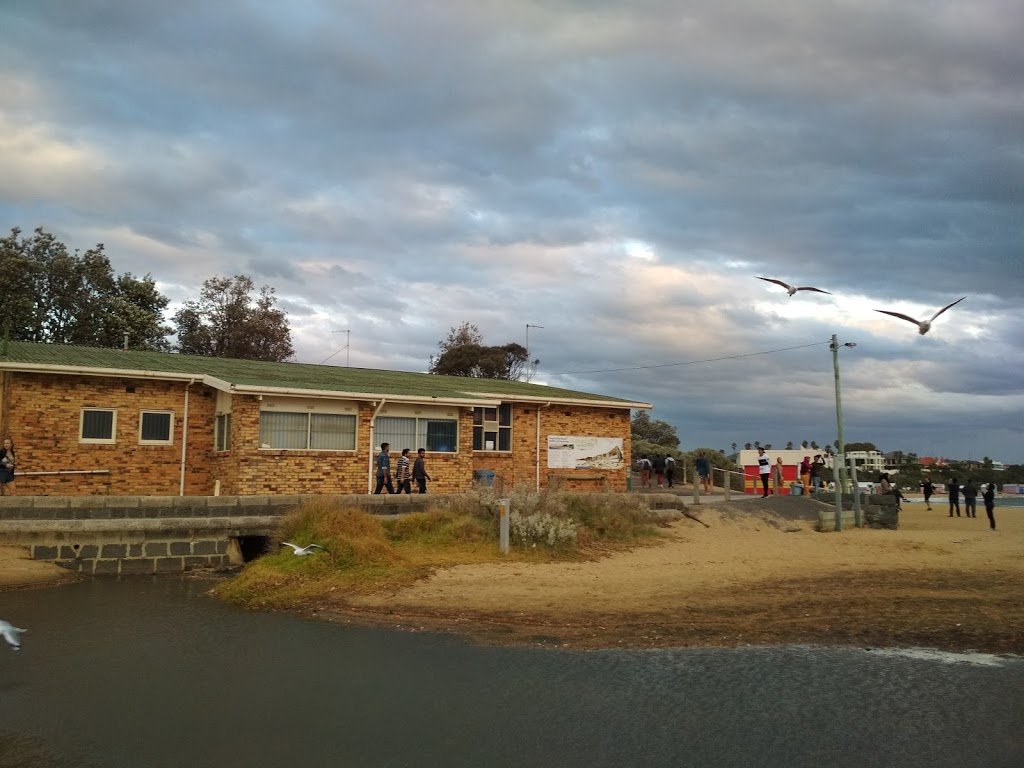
0, 578, 1024, 768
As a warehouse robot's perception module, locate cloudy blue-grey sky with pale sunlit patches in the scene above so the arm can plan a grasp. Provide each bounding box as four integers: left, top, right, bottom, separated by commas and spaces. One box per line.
0, 0, 1024, 463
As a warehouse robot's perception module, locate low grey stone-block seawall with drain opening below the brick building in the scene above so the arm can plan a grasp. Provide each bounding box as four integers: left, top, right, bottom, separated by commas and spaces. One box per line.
0, 495, 436, 574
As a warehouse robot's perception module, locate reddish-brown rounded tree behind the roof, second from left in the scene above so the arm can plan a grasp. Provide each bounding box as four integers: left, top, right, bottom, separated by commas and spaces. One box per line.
174, 274, 295, 362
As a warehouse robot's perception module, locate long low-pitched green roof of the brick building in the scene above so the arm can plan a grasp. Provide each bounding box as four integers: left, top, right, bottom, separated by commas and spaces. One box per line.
0, 341, 649, 408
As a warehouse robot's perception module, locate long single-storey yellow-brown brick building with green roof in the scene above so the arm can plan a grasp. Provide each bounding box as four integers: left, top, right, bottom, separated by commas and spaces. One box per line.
0, 342, 651, 496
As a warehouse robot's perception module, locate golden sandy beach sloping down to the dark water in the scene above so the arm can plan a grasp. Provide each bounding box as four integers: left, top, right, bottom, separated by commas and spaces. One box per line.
335, 498, 1024, 653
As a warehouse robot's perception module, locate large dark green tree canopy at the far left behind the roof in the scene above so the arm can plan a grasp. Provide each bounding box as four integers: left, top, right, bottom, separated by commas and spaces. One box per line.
0, 227, 172, 350
